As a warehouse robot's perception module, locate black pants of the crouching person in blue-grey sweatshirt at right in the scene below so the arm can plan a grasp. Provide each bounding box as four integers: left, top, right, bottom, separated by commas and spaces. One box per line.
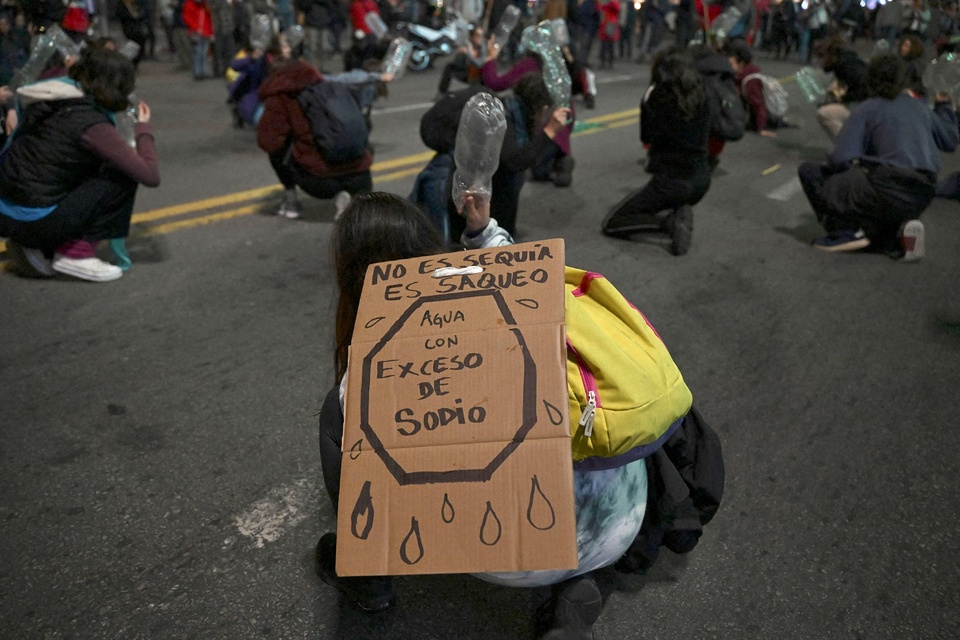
797, 162, 937, 250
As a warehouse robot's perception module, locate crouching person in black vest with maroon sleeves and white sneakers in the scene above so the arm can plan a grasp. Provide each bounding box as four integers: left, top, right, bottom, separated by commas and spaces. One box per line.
0, 48, 160, 282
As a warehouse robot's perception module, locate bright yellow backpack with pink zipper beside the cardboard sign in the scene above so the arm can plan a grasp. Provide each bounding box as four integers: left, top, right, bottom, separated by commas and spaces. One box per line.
564, 267, 693, 461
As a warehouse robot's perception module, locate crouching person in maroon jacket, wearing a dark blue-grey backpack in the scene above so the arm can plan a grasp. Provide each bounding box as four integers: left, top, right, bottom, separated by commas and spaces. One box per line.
257, 50, 373, 219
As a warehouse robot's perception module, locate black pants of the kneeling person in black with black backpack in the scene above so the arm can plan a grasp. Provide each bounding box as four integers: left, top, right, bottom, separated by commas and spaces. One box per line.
603, 166, 710, 233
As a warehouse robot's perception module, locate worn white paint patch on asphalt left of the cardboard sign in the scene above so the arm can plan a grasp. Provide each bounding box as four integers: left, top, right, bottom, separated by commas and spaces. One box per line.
233, 478, 316, 549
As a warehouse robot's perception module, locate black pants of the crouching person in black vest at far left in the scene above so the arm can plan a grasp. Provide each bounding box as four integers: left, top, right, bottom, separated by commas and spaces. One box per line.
0, 169, 137, 254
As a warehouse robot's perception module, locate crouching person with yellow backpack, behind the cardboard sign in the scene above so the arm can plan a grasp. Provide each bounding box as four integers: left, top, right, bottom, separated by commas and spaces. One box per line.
317, 193, 723, 639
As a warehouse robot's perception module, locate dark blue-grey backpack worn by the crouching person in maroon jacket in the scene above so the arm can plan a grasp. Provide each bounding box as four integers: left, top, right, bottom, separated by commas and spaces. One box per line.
297, 81, 370, 165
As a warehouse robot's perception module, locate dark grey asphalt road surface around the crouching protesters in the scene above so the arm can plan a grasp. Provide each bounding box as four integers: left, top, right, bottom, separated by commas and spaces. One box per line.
0, 42, 960, 640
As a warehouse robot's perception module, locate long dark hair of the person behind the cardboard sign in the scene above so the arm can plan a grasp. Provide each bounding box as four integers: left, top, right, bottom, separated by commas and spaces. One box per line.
332, 191, 446, 382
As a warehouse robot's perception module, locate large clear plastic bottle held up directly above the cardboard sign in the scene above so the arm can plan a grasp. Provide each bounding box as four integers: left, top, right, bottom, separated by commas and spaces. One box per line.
452, 93, 507, 211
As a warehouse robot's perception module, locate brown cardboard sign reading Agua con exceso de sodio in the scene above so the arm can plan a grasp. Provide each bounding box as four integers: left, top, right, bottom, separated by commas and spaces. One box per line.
337, 240, 577, 576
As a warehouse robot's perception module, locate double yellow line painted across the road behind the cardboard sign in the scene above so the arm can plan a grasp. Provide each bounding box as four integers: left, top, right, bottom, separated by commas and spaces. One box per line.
0, 109, 639, 251
